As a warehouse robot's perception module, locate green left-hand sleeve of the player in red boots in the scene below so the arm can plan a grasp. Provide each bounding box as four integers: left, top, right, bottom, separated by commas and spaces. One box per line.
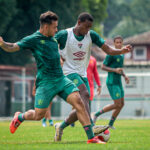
17, 35, 35, 50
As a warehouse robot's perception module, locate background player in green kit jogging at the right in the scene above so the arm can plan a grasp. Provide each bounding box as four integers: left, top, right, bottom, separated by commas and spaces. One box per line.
93, 36, 129, 129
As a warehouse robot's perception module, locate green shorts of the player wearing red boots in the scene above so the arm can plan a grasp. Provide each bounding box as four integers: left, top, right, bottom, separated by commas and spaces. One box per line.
35, 76, 79, 108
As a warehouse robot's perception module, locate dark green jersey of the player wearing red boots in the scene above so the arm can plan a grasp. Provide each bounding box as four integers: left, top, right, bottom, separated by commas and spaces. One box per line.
17, 31, 63, 83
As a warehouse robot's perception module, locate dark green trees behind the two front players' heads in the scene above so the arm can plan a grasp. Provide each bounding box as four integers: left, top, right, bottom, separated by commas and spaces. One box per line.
0, 0, 107, 65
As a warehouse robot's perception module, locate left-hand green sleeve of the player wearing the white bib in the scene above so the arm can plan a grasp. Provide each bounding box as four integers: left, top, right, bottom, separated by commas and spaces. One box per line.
55, 30, 68, 50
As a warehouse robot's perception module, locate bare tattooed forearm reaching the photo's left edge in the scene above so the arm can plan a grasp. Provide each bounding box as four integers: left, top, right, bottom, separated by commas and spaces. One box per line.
0, 37, 20, 52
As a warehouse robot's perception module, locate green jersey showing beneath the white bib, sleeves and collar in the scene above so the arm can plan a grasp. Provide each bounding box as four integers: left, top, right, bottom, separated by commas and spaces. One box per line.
55, 30, 105, 50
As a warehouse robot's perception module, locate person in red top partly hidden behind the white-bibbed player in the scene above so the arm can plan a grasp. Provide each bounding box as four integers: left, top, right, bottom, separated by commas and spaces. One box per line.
87, 55, 101, 108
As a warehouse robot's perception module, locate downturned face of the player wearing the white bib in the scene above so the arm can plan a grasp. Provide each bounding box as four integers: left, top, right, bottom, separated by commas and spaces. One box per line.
78, 20, 92, 35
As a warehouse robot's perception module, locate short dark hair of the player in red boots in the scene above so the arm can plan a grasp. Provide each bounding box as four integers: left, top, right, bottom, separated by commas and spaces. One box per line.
40, 11, 58, 25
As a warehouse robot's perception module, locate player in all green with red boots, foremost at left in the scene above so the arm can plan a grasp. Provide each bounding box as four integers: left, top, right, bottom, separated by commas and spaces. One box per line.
0, 11, 105, 144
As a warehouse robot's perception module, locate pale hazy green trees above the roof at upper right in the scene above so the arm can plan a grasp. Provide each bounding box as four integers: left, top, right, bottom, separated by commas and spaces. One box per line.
104, 0, 150, 37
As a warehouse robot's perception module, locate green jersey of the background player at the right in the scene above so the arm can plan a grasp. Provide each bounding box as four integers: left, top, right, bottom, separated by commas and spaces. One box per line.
103, 55, 124, 84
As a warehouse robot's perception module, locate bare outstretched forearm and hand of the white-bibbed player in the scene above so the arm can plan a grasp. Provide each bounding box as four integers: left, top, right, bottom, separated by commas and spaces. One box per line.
101, 43, 132, 55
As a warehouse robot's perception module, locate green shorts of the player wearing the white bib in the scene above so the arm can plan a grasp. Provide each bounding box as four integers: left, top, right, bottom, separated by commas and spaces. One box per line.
67, 73, 90, 94
